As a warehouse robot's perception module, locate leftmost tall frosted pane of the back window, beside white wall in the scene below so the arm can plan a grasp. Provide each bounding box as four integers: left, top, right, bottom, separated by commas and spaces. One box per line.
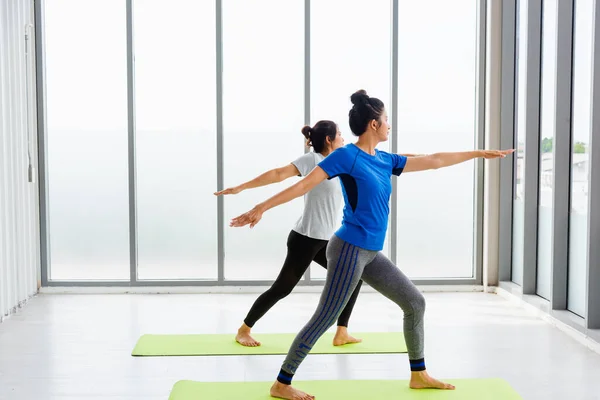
44, 0, 129, 280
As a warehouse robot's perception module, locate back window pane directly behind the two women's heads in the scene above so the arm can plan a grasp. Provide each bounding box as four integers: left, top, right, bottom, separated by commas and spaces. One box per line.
311, 0, 394, 278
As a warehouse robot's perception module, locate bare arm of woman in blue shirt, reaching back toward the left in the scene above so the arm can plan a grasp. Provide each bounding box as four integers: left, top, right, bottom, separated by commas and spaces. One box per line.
229, 166, 327, 228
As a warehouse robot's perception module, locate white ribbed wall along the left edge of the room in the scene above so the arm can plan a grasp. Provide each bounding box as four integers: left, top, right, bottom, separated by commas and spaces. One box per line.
0, 0, 40, 321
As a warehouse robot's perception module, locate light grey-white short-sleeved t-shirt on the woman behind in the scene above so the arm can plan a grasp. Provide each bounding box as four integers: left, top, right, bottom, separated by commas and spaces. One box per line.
292, 151, 343, 240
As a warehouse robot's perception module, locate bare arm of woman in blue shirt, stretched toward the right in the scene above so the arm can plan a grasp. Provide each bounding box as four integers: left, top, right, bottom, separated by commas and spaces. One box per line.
403, 149, 514, 172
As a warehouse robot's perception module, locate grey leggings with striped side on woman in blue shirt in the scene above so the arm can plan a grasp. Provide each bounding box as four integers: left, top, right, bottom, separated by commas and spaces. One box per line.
281, 236, 425, 374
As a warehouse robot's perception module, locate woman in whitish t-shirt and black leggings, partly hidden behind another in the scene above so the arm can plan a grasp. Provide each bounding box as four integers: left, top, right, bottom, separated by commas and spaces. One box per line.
215, 120, 361, 347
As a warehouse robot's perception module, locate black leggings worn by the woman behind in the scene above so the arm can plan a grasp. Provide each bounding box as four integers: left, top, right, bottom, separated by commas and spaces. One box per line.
244, 231, 362, 327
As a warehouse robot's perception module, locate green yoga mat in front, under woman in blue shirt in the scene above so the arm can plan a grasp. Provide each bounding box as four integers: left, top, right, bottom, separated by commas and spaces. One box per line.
169, 379, 522, 400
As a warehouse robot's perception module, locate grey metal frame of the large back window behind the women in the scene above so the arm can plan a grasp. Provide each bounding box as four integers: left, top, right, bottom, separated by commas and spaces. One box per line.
35, 0, 488, 287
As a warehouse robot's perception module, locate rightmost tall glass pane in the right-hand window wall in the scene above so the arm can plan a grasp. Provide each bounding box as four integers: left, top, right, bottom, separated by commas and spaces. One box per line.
567, 0, 594, 316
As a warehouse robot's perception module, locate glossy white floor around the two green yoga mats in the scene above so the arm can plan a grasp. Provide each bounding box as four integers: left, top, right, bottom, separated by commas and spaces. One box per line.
0, 293, 600, 400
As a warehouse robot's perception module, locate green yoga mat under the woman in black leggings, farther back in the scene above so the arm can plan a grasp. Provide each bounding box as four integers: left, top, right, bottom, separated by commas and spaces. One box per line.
131, 332, 406, 356
